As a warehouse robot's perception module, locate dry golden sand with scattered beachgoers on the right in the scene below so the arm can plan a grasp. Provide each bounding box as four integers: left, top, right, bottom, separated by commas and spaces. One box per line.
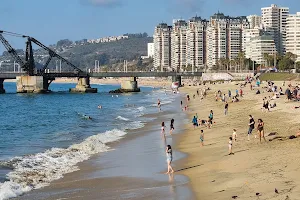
176, 83, 300, 200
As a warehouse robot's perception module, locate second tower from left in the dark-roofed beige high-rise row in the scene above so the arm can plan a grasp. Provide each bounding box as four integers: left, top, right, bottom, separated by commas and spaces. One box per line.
171, 20, 188, 71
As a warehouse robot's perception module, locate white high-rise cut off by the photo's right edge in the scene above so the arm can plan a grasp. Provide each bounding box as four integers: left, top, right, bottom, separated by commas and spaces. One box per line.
286, 12, 300, 61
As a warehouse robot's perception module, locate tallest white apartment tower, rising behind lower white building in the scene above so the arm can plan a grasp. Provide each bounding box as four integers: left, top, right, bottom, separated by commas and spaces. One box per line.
261, 4, 289, 54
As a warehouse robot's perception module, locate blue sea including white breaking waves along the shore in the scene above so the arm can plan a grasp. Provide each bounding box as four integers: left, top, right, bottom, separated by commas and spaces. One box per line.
0, 83, 178, 200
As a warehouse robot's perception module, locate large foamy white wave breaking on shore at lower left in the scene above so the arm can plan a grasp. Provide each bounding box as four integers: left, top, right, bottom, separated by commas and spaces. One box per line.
0, 129, 126, 200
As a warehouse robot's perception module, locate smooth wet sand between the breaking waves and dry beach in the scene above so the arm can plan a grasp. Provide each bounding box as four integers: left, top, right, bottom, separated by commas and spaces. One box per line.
16, 97, 194, 200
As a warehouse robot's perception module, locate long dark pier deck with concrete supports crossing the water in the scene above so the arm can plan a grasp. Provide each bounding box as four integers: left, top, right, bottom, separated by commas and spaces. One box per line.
0, 71, 202, 93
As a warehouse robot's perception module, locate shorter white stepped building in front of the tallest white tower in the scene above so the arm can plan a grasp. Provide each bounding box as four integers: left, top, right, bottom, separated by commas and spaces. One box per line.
248, 33, 276, 66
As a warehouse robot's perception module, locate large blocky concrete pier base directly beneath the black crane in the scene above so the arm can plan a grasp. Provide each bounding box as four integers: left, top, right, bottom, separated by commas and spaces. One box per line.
17, 76, 49, 93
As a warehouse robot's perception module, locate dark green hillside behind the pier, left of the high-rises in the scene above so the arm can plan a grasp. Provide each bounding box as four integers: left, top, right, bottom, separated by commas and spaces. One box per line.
0, 34, 153, 70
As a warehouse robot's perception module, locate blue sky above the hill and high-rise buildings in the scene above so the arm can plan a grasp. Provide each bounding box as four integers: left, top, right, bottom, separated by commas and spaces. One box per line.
0, 0, 300, 52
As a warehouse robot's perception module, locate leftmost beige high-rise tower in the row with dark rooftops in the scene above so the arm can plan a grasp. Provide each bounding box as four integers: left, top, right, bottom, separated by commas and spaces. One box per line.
153, 23, 172, 71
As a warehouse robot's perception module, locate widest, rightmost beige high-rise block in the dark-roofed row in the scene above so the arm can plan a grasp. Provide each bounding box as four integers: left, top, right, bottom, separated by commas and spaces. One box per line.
206, 13, 249, 68
